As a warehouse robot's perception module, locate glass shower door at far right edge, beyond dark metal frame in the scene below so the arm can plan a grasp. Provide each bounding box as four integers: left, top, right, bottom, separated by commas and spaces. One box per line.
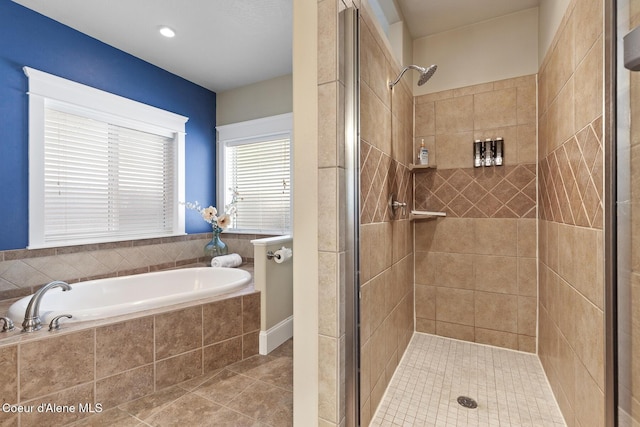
615, 0, 640, 426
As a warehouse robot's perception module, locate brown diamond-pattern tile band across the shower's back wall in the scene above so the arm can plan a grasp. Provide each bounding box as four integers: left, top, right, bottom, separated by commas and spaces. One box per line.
415, 164, 536, 218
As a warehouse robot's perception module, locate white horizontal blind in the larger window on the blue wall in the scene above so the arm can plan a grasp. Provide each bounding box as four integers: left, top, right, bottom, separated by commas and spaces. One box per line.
44, 108, 175, 243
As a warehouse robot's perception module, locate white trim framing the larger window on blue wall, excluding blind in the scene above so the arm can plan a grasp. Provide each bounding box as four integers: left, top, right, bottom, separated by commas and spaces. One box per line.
23, 67, 189, 249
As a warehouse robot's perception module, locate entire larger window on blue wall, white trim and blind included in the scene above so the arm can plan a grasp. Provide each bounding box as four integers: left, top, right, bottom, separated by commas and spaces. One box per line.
24, 67, 188, 248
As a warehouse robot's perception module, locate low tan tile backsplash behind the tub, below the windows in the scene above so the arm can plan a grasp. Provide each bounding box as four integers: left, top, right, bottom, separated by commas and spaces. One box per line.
0, 233, 269, 301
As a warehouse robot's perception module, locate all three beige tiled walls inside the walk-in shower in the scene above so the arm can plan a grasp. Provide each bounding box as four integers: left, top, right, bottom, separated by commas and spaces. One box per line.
330, 0, 606, 425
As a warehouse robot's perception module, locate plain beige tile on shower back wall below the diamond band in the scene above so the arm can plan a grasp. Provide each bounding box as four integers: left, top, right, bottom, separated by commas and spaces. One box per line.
415, 218, 537, 352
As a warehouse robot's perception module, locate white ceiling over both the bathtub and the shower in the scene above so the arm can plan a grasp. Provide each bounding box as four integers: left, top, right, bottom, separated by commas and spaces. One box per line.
13, 0, 540, 92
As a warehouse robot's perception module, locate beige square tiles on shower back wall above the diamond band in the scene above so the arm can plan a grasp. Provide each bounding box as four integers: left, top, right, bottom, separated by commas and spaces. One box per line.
414, 76, 536, 169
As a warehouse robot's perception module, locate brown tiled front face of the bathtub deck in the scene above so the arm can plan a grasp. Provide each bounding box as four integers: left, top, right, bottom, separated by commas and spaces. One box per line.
0, 286, 260, 427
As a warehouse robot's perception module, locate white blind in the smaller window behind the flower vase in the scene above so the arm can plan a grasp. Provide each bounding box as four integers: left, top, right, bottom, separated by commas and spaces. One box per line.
225, 138, 291, 232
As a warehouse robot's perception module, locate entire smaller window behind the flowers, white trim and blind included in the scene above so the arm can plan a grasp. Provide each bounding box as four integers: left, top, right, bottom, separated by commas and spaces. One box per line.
217, 114, 292, 234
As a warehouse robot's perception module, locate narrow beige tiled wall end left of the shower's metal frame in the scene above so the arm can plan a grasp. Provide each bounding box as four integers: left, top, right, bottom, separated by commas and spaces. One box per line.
316, 0, 352, 426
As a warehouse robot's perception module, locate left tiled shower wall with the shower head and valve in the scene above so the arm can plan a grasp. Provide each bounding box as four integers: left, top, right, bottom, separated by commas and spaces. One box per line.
360, 5, 414, 426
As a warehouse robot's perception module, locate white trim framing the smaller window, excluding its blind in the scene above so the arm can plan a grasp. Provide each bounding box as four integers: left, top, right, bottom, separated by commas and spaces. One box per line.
216, 113, 294, 235
